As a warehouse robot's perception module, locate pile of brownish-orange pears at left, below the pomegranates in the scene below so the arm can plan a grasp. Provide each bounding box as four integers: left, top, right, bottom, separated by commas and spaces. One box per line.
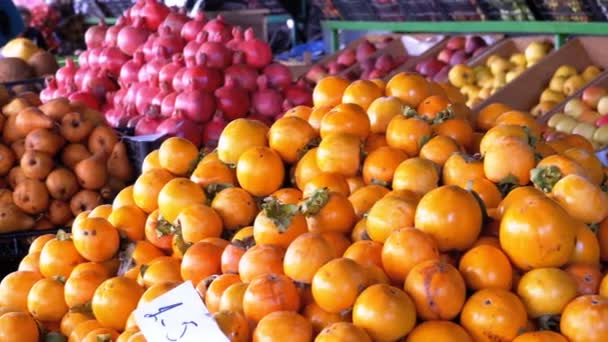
0, 89, 134, 233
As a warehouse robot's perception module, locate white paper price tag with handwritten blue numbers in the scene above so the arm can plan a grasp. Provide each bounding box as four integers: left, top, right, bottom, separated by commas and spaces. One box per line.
135, 281, 229, 342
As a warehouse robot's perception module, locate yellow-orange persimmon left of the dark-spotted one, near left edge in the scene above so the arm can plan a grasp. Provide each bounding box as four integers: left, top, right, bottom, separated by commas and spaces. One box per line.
38, 232, 85, 279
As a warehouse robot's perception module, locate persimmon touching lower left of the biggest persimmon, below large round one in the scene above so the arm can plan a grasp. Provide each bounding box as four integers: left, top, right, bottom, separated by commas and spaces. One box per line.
458, 240, 513, 291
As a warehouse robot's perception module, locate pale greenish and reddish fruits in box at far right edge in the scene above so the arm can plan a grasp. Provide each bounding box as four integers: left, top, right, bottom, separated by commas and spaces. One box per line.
547, 86, 608, 149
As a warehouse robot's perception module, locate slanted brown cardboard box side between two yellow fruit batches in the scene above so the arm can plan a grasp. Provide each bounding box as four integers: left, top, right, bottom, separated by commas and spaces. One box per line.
473, 37, 608, 113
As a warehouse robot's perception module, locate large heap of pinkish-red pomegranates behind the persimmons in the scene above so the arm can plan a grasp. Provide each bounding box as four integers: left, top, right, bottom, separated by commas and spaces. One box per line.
41, 0, 312, 146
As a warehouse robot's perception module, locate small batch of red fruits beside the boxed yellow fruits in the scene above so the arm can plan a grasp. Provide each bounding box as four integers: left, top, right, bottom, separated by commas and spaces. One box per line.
416, 35, 487, 80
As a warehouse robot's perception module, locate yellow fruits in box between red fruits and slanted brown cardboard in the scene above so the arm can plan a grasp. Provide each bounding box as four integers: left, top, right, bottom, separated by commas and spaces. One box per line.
448, 41, 551, 107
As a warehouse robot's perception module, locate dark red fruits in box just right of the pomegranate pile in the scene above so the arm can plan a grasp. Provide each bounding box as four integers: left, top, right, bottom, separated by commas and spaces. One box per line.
304, 35, 400, 84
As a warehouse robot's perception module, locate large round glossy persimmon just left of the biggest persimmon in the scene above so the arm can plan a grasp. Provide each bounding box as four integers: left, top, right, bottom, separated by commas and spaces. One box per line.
414, 185, 482, 252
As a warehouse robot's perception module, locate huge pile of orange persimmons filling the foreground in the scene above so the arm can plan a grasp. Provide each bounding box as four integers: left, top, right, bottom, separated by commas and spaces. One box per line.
0, 73, 608, 342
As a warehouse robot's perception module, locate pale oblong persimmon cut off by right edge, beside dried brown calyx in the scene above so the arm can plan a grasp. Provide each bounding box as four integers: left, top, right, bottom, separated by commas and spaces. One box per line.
551, 174, 608, 223
